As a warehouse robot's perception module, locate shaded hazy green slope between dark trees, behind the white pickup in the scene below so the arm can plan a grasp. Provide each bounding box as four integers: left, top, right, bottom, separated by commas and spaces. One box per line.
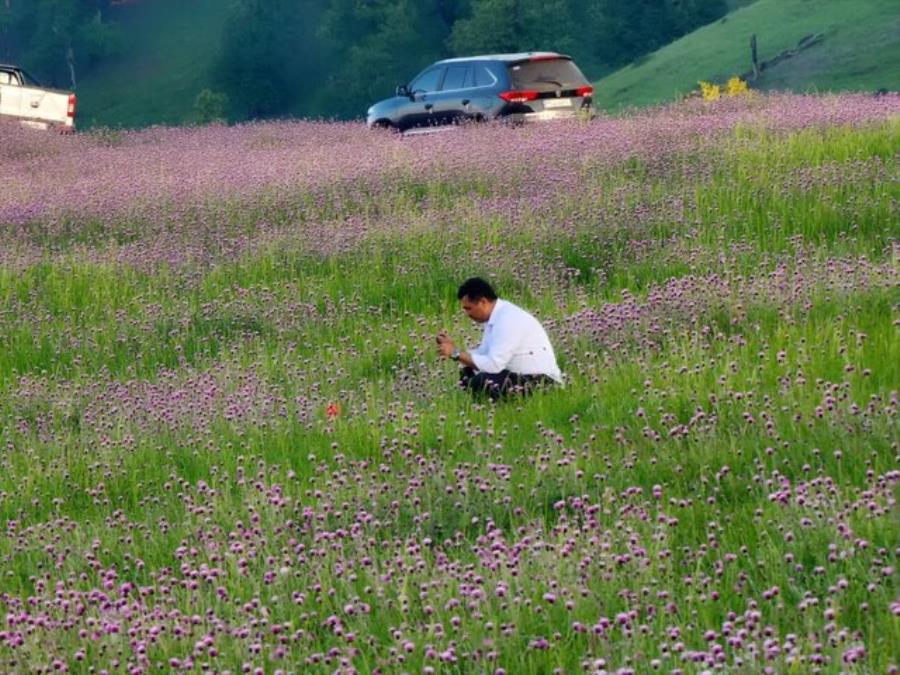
78, 0, 229, 128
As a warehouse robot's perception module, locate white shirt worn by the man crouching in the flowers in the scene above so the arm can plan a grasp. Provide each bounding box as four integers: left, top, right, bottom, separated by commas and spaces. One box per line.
469, 299, 562, 382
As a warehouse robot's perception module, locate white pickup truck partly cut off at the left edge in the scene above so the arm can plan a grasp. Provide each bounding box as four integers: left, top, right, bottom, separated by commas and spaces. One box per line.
0, 65, 75, 131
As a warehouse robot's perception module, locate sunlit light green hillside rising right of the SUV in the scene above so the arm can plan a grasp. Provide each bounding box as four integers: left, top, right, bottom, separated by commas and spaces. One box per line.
597, 0, 900, 110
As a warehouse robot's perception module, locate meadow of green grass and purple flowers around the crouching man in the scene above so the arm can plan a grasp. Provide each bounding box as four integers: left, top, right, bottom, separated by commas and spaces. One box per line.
0, 96, 900, 673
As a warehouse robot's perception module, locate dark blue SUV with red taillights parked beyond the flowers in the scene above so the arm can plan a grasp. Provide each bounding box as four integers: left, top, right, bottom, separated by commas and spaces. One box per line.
366, 52, 594, 131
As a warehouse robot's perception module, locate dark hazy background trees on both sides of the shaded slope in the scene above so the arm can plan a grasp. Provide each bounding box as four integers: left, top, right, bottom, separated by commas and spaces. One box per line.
0, 0, 727, 120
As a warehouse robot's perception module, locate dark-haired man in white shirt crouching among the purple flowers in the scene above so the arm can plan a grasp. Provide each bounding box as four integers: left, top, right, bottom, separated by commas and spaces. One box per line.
437, 277, 562, 401
